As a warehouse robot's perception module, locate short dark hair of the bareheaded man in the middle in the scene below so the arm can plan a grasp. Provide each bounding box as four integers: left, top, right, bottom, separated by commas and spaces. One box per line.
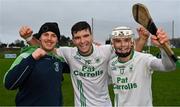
71, 21, 91, 36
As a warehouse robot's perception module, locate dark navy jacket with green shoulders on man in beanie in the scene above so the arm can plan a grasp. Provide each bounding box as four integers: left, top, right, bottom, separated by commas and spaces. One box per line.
4, 46, 69, 106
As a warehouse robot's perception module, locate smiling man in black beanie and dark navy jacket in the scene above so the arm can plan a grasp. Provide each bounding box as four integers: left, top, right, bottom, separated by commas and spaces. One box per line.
4, 22, 69, 106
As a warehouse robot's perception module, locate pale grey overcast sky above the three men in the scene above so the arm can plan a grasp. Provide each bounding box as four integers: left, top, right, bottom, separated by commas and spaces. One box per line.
0, 0, 180, 43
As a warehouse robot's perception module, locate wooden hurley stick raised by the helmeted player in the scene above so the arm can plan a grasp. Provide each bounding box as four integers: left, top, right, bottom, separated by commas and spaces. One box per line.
132, 3, 178, 62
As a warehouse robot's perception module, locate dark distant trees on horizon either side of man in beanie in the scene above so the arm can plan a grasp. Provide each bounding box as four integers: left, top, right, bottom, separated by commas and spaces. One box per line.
0, 35, 72, 48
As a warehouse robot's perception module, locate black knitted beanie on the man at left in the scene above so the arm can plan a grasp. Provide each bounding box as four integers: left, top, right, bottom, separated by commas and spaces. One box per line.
37, 22, 60, 40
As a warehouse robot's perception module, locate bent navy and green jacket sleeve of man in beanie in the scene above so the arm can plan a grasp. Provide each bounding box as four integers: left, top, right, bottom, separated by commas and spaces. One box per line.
3, 55, 35, 90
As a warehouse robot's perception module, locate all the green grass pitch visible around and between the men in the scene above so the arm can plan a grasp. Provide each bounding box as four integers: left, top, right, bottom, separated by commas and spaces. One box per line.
0, 48, 180, 106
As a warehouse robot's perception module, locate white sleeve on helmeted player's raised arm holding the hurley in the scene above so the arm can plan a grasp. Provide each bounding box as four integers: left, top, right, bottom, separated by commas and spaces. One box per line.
150, 49, 176, 71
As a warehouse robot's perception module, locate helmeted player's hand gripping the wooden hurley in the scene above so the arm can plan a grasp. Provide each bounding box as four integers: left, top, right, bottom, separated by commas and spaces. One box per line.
151, 28, 170, 47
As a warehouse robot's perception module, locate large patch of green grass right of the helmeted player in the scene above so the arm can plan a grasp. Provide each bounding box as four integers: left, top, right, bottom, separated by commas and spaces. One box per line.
152, 69, 180, 106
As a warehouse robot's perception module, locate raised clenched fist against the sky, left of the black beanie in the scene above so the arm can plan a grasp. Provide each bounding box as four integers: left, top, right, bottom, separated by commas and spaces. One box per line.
19, 26, 33, 39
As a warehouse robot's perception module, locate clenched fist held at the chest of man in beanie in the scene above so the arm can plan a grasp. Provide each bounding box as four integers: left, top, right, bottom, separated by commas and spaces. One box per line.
32, 48, 46, 60
